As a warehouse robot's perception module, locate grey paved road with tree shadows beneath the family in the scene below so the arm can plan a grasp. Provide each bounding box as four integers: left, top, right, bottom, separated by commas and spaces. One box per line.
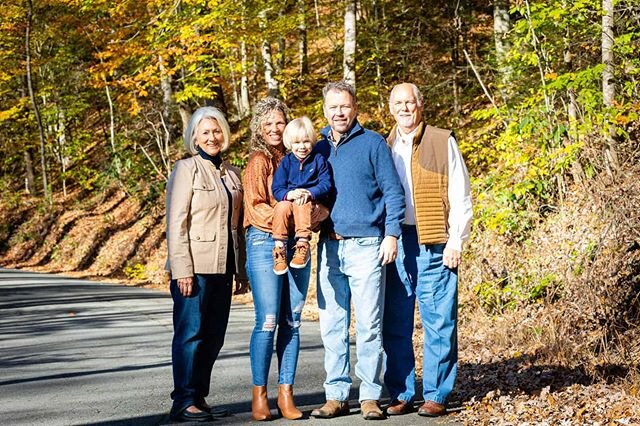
0, 269, 455, 425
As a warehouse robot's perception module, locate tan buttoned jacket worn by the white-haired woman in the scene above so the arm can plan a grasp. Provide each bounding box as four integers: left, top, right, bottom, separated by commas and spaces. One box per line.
165, 155, 246, 279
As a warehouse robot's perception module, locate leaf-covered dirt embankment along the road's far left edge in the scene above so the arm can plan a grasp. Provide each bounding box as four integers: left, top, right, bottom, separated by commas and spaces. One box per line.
0, 188, 166, 287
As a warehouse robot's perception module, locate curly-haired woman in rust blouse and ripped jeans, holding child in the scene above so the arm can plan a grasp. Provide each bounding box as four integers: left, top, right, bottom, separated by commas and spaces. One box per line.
243, 98, 310, 420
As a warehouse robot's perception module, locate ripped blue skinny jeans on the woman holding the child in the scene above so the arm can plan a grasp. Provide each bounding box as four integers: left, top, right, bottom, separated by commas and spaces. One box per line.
246, 226, 311, 386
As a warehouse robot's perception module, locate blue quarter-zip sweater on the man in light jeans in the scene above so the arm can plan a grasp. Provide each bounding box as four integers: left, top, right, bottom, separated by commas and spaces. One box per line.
316, 121, 405, 237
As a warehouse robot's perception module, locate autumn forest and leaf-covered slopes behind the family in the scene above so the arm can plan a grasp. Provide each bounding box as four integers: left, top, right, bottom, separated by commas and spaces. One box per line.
0, 0, 640, 424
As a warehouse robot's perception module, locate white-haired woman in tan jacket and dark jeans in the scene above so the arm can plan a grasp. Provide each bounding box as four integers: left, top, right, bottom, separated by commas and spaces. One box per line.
166, 107, 247, 421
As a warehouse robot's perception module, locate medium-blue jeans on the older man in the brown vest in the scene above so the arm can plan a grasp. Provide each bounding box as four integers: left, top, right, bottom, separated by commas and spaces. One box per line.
383, 226, 458, 404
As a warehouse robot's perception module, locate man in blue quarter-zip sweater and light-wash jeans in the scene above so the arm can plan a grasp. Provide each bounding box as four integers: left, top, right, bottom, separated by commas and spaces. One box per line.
311, 81, 405, 420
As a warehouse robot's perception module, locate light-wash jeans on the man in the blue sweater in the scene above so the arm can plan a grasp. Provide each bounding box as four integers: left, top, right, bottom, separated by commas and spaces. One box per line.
318, 237, 384, 401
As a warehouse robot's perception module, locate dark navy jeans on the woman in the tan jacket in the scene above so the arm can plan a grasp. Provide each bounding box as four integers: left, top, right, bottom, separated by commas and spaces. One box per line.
169, 274, 232, 414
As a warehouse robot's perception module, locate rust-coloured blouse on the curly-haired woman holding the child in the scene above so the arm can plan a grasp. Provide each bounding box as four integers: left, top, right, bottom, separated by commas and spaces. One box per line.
242, 147, 284, 233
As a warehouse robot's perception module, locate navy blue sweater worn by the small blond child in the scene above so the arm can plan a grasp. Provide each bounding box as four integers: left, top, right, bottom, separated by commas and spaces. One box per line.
271, 149, 332, 204
